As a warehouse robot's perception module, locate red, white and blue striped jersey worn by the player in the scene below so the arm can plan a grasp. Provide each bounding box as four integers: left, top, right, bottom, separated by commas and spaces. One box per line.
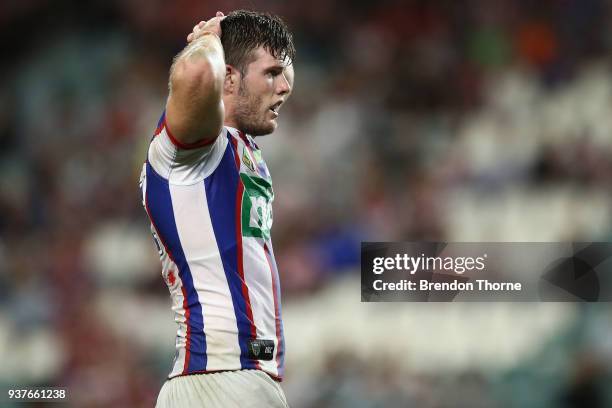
141, 111, 285, 380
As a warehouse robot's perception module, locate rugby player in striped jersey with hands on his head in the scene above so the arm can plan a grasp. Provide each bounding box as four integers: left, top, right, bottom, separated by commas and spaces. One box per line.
141, 10, 295, 408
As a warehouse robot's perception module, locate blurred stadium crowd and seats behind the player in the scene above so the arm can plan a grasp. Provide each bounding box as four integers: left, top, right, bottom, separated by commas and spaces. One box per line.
0, 0, 612, 408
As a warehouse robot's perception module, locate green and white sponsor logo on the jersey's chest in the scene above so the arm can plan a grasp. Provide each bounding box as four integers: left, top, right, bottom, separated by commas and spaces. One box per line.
240, 173, 274, 239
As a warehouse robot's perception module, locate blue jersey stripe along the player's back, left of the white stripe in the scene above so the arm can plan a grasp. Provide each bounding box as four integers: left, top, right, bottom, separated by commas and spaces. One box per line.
147, 162, 207, 373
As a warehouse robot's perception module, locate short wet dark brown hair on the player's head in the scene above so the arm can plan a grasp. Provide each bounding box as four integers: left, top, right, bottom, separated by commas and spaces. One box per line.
221, 10, 295, 75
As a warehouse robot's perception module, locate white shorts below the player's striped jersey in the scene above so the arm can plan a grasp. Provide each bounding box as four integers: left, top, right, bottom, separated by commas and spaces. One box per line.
155, 370, 289, 408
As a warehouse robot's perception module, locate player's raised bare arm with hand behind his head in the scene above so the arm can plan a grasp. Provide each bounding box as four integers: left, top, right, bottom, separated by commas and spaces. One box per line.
166, 12, 225, 145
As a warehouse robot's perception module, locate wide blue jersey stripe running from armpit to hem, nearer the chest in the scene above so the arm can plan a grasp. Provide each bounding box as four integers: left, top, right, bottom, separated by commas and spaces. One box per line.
204, 135, 257, 369
